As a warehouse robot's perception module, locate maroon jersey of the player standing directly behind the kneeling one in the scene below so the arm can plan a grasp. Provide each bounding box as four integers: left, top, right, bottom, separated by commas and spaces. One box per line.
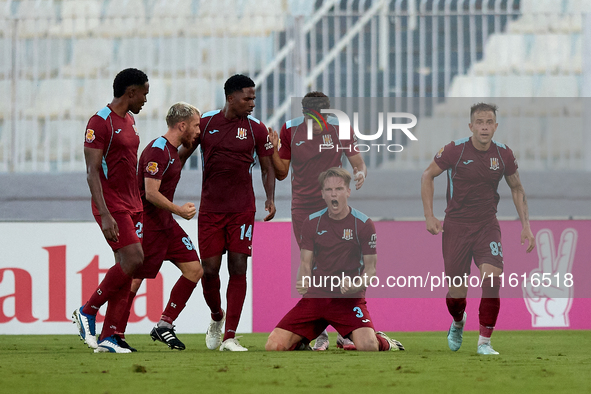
279, 116, 359, 208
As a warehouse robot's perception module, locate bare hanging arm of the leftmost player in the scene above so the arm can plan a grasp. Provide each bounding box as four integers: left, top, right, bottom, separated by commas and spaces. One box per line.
84, 147, 119, 242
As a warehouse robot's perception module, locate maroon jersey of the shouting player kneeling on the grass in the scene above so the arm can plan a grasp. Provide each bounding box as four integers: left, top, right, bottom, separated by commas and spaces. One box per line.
301, 208, 377, 298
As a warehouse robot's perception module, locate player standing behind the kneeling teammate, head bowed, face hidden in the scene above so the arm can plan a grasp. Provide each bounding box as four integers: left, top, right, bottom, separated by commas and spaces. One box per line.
269, 92, 367, 350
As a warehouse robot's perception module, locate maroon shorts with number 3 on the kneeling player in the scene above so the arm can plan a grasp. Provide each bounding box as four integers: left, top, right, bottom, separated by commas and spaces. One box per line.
277, 298, 373, 341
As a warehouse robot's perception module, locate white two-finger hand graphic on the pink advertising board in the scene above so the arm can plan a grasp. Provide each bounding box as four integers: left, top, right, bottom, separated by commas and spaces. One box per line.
523, 228, 577, 327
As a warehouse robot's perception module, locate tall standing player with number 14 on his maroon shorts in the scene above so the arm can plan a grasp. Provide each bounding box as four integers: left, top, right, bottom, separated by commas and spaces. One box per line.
180, 75, 275, 351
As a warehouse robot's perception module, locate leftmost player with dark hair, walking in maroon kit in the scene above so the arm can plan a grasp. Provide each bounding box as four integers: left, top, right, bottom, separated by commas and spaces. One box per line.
72, 68, 149, 353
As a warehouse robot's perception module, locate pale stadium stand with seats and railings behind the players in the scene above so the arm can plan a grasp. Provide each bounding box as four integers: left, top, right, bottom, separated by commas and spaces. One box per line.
0, 0, 591, 172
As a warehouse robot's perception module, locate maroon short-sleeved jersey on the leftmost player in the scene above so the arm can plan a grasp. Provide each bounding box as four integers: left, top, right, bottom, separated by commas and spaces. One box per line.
84, 105, 142, 215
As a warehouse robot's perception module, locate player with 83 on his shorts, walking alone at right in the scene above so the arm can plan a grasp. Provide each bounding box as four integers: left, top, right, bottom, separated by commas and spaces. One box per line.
421, 103, 535, 354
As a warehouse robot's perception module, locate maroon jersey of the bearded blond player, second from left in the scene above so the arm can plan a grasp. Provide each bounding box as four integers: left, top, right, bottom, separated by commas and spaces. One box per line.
137, 137, 183, 231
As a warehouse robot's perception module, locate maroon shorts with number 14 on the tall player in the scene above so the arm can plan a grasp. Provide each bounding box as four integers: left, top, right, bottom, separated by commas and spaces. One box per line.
197, 211, 254, 259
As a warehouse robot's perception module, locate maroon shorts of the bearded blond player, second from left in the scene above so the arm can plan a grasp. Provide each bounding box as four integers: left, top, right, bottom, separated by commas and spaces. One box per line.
133, 221, 199, 279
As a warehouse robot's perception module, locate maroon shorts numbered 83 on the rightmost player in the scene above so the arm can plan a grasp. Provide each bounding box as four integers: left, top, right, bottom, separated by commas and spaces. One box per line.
442, 218, 503, 280
